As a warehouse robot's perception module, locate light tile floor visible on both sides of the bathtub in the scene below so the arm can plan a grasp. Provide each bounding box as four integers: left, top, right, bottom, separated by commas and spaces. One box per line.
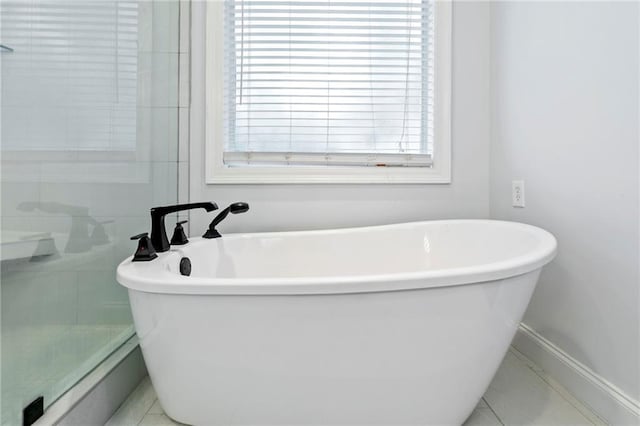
107, 349, 605, 426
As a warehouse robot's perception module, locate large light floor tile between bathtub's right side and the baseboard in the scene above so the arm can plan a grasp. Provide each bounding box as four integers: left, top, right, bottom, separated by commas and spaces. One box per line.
484, 352, 592, 426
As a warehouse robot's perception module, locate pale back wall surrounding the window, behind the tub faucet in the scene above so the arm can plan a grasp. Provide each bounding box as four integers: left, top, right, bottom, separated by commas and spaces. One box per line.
189, 2, 490, 235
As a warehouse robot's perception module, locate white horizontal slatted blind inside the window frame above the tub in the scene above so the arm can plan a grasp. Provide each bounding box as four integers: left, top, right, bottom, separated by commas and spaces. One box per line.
223, 0, 434, 167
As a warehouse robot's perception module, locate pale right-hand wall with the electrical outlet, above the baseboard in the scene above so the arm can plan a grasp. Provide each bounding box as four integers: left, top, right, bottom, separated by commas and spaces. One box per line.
490, 2, 640, 406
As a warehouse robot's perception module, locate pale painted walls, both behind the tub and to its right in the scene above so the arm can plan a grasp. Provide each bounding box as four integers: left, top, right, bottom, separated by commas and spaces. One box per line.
188, 2, 640, 418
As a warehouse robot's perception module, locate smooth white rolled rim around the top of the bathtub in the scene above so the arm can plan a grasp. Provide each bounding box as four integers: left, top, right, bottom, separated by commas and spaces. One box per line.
116, 219, 557, 295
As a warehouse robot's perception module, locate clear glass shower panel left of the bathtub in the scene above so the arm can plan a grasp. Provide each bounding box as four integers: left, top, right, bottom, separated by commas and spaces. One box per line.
0, 0, 180, 425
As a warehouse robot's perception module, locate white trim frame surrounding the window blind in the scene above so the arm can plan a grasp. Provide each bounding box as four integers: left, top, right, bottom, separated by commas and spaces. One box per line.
204, 1, 452, 184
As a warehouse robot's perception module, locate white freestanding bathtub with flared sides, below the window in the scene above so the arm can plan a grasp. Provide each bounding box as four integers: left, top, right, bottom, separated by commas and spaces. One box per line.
118, 220, 556, 426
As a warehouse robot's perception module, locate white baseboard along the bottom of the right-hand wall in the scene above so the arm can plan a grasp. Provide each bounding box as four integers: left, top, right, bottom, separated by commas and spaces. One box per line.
513, 324, 640, 426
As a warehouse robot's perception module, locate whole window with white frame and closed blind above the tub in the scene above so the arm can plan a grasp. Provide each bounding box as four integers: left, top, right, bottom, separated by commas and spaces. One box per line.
206, 0, 451, 183
